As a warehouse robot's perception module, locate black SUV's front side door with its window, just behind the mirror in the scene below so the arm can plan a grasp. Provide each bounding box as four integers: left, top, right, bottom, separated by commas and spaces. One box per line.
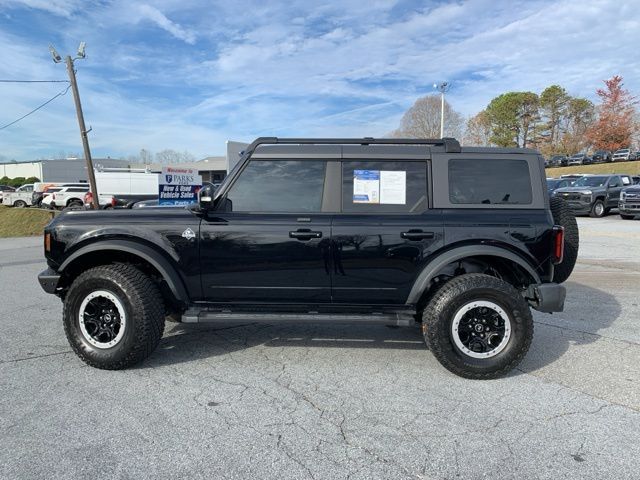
200, 159, 331, 304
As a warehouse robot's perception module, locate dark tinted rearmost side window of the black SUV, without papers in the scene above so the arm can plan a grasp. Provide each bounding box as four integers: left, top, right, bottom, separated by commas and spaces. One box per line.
449, 158, 533, 205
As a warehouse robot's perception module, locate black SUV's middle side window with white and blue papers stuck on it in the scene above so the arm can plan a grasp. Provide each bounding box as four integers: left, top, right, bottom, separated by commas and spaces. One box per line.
342, 160, 427, 213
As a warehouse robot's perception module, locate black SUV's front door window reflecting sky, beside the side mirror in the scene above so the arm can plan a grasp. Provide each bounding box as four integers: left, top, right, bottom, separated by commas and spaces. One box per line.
227, 160, 327, 213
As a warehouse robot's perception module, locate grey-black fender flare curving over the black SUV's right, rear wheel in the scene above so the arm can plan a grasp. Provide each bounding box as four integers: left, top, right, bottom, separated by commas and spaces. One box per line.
406, 245, 541, 304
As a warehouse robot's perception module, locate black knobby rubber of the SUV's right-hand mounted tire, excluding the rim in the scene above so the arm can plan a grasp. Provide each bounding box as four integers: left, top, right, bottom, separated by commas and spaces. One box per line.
422, 273, 533, 380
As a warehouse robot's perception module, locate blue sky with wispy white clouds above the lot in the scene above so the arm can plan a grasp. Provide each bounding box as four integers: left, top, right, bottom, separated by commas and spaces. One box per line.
0, 0, 640, 160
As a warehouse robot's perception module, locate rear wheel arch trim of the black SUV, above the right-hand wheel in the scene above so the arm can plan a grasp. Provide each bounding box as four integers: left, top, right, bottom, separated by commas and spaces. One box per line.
406, 245, 541, 305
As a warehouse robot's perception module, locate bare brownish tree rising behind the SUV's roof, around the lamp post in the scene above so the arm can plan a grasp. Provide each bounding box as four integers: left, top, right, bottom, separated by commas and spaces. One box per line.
391, 95, 464, 138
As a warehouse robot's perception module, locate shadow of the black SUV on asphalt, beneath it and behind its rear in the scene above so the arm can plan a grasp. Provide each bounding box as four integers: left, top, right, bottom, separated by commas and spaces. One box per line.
137, 282, 622, 375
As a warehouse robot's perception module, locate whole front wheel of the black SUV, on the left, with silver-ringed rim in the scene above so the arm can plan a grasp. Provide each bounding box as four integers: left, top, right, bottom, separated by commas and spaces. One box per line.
63, 264, 164, 370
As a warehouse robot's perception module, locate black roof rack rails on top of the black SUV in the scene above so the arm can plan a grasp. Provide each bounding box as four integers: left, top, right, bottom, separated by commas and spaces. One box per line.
242, 137, 461, 161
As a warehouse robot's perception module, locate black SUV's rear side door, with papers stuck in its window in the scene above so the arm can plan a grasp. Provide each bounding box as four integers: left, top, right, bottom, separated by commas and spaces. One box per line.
332, 146, 443, 305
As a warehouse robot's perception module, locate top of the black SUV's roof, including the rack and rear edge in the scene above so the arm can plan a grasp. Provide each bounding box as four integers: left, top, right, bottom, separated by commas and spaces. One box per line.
248, 137, 538, 158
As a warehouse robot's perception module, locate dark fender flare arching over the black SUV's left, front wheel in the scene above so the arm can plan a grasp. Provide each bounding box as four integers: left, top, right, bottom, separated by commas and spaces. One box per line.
58, 240, 189, 305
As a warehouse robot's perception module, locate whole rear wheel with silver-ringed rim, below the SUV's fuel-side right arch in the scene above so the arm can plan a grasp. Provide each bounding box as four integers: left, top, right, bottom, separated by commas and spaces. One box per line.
422, 273, 533, 379
